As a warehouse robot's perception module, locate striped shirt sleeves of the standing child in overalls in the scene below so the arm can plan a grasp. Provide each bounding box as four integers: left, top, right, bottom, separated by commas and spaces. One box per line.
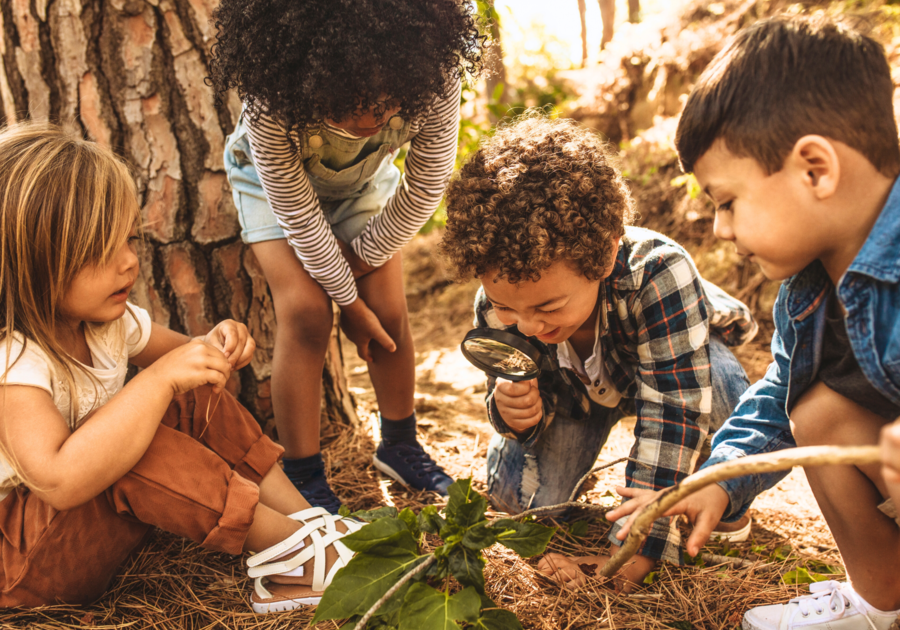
247, 83, 461, 305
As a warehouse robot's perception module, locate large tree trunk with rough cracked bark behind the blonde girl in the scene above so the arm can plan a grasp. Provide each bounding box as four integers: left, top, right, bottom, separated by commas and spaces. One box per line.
0, 0, 358, 434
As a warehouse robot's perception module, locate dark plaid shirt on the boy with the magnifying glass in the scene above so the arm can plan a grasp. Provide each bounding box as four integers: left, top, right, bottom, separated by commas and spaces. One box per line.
475, 227, 757, 563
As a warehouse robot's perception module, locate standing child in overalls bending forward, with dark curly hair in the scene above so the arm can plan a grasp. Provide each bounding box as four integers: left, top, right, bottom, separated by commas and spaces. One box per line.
210, 0, 483, 524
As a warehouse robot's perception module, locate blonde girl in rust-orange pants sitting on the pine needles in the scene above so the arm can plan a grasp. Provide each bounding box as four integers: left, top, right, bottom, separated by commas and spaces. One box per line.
0, 123, 357, 612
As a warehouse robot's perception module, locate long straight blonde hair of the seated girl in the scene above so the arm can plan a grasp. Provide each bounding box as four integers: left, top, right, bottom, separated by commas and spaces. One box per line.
0, 122, 140, 472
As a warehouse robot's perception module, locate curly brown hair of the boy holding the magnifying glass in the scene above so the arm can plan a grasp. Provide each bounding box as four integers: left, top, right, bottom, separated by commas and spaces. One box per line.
440, 112, 634, 284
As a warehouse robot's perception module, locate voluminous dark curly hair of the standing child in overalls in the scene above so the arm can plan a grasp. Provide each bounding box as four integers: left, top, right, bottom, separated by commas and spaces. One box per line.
209, 0, 485, 136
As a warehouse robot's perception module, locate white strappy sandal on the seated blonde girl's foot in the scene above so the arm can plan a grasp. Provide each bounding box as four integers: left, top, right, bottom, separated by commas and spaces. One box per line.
247, 508, 365, 613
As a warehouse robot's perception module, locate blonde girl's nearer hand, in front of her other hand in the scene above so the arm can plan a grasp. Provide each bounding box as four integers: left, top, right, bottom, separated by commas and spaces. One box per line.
142, 339, 231, 396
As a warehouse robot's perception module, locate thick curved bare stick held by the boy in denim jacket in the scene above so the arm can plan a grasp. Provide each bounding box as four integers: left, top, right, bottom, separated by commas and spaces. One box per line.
599, 446, 881, 577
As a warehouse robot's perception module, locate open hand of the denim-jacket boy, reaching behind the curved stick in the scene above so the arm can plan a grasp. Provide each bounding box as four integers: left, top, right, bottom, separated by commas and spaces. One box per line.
606, 484, 730, 556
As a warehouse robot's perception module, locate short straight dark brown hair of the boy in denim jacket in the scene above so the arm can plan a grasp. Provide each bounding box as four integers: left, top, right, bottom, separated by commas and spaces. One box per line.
675, 16, 900, 177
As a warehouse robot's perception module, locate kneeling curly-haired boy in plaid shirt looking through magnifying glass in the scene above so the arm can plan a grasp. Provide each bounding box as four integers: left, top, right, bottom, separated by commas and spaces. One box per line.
441, 115, 756, 588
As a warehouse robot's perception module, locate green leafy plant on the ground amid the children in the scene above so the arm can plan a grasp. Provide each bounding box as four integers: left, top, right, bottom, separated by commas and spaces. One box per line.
313, 479, 556, 630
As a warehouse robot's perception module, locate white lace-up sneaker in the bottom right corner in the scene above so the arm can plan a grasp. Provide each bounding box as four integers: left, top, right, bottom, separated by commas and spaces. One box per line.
741, 580, 900, 630
